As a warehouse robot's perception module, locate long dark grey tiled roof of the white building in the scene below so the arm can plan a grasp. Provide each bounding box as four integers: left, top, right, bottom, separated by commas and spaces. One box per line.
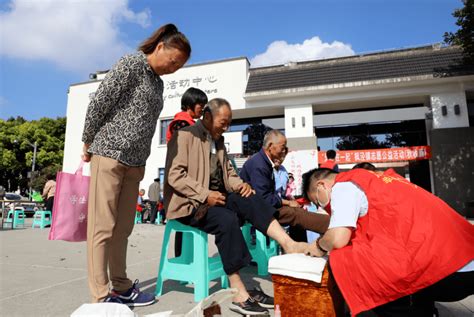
246, 46, 474, 93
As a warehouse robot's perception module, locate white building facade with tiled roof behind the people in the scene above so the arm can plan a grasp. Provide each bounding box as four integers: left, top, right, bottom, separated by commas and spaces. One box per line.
63, 45, 474, 212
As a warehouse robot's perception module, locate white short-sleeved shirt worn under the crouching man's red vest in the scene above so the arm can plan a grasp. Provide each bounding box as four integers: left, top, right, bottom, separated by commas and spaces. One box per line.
328, 182, 474, 272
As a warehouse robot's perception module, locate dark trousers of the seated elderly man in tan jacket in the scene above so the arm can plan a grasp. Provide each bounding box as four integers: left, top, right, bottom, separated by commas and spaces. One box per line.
176, 193, 276, 275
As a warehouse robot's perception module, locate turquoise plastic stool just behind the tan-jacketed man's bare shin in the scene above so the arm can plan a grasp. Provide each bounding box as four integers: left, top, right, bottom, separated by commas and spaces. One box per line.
242, 223, 278, 276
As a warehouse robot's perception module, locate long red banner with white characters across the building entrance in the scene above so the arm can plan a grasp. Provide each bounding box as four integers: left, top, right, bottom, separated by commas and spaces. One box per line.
318, 146, 431, 164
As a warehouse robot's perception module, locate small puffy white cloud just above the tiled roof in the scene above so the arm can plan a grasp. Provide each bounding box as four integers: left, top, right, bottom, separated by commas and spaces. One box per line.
250, 36, 354, 67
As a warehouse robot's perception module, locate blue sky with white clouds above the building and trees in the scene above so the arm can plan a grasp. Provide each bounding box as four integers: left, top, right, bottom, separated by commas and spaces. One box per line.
0, 0, 462, 120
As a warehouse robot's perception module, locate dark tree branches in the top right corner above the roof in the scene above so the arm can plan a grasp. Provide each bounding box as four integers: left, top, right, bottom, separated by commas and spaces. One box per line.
444, 0, 474, 65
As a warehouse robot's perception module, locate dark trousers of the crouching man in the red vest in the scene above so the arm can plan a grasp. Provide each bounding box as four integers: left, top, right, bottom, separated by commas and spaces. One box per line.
328, 260, 474, 317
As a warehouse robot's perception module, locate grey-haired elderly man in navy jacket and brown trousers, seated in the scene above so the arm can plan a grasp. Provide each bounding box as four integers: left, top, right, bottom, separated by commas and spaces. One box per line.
240, 130, 329, 237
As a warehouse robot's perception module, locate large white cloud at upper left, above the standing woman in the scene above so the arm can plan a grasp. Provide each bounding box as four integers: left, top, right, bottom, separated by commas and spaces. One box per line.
0, 0, 150, 72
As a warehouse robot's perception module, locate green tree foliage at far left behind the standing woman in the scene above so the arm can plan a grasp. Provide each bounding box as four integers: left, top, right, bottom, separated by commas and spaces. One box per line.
0, 117, 66, 192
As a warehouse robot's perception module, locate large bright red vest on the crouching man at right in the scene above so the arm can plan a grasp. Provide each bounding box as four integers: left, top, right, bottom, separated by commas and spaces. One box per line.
330, 169, 474, 316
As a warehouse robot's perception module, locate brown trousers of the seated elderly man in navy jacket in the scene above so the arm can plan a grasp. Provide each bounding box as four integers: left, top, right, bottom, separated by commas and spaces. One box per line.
276, 206, 329, 233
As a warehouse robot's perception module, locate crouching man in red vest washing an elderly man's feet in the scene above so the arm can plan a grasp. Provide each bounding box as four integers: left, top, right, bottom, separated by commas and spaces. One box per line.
303, 169, 474, 317
